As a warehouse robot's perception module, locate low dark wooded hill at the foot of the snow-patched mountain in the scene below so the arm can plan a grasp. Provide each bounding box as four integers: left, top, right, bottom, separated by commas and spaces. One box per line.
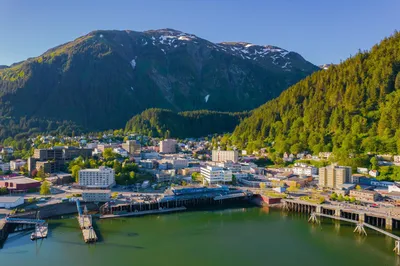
125, 108, 249, 138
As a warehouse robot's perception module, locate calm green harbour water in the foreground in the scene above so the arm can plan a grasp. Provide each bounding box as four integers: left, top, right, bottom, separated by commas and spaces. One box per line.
0, 208, 400, 266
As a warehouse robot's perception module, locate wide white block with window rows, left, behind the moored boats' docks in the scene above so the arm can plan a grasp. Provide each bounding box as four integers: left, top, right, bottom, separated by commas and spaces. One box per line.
79, 166, 115, 188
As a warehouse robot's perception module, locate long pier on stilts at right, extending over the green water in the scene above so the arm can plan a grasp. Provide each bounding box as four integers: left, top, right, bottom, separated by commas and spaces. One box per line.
282, 199, 400, 255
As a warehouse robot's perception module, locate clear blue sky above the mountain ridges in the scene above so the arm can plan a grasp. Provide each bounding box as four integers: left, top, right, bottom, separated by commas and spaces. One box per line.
0, 0, 400, 65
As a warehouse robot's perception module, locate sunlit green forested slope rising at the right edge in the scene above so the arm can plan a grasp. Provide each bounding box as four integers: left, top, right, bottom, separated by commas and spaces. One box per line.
232, 32, 400, 158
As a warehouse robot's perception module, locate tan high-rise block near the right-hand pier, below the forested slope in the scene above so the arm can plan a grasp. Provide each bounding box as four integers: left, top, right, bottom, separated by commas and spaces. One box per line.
318, 165, 351, 188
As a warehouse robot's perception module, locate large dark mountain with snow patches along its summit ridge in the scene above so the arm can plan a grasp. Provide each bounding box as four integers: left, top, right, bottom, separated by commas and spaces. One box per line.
0, 29, 318, 130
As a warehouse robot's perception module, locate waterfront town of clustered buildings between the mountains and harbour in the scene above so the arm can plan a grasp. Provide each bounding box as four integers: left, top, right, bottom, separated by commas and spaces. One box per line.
0, 134, 400, 219
